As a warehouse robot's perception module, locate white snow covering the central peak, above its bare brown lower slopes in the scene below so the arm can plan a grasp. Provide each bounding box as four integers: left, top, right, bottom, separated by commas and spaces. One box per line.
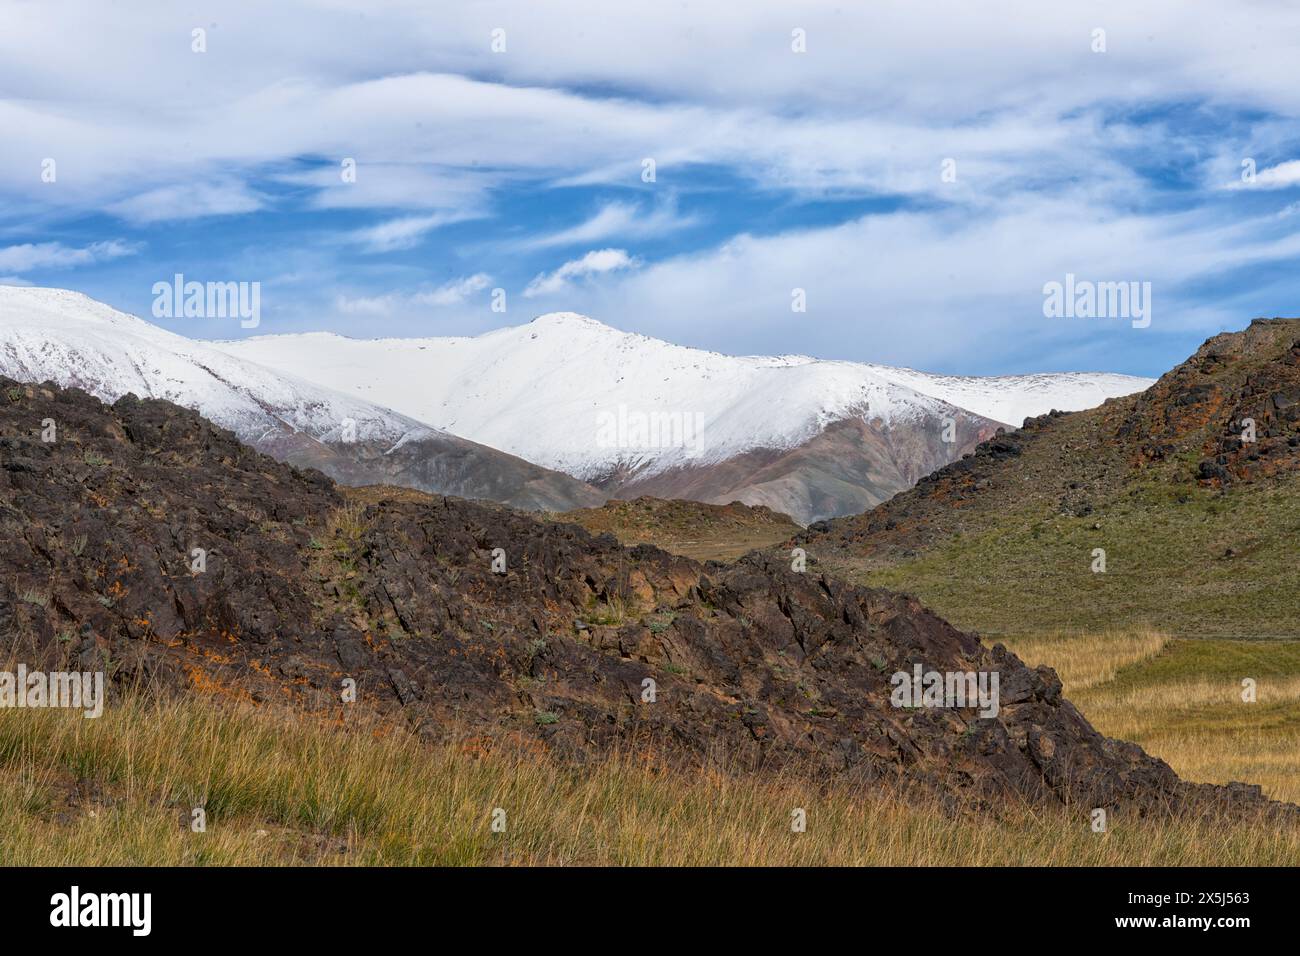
213, 312, 1151, 481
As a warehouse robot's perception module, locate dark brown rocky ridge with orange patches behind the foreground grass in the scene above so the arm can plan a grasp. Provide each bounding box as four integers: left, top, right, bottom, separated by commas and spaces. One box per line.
0, 378, 1295, 813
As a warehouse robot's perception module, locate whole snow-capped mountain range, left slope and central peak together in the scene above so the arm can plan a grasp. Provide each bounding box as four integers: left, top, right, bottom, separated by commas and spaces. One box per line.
0, 286, 1151, 523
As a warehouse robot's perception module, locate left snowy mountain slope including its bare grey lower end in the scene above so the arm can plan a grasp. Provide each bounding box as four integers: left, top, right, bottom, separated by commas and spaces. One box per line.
0, 286, 605, 509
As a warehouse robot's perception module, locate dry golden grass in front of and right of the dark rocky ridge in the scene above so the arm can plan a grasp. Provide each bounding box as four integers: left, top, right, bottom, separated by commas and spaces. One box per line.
0, 632, 1300, 865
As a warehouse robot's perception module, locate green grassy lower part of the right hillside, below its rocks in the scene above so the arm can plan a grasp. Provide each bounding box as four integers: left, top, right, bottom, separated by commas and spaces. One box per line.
811, 480, 1300, 639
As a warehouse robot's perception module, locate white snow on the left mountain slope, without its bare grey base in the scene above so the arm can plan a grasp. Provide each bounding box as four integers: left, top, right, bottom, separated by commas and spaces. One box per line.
0, 286, 429, 444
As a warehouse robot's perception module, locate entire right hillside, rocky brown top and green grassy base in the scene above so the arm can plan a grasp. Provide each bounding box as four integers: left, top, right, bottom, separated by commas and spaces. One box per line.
803, 319, 1300, 637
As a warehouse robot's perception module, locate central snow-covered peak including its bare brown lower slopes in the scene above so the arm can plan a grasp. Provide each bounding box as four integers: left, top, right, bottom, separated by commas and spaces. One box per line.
213, 313, 1149, 522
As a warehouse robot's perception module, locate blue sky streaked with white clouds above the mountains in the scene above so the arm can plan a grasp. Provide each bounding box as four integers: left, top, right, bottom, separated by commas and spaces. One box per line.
0, 0, 1300, 375
